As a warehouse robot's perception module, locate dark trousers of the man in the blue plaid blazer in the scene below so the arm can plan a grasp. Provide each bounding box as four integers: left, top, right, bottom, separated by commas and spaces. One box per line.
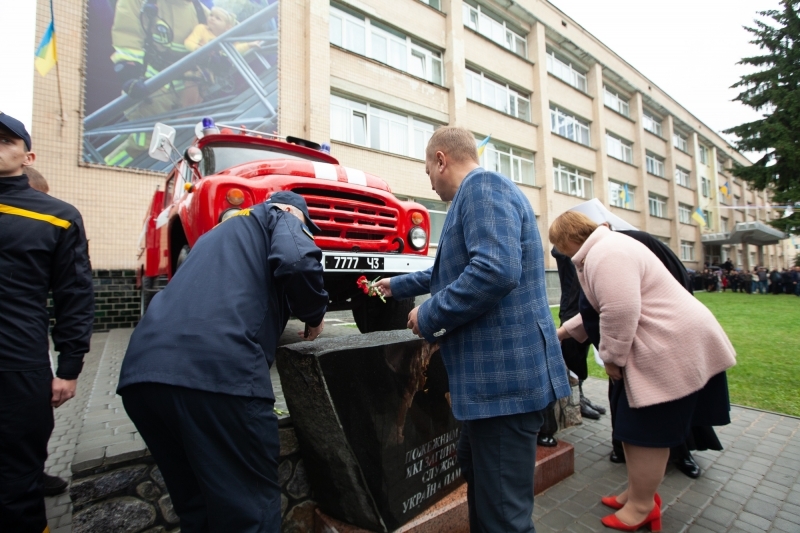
458, 410, 544, 533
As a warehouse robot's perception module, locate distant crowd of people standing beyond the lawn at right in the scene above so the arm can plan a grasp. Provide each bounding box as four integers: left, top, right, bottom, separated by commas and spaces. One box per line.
692, 260, 800, 296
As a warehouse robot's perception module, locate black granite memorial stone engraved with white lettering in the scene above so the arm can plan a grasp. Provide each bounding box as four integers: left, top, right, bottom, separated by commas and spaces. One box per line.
276, 331, 462, 531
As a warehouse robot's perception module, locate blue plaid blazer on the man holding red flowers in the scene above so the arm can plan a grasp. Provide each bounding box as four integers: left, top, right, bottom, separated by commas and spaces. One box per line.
391, 168, 570, 420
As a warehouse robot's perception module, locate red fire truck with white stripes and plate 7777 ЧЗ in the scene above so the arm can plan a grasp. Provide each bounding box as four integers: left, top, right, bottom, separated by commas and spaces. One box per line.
139, 119, 433, 332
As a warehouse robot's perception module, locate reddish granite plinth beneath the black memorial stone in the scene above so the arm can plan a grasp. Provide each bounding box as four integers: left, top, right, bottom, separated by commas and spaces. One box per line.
314, 441, 575, 533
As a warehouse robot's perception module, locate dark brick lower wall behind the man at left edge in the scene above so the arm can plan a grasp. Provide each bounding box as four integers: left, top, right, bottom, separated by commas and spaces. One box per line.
47, 270, 140, 332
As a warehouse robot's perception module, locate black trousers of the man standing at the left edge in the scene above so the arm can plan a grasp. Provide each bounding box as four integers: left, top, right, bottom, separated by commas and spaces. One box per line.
0, 368, 54, 533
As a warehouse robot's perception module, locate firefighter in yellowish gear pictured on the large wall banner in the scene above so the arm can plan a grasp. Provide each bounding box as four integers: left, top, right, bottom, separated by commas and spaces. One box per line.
105, 0, 209, 167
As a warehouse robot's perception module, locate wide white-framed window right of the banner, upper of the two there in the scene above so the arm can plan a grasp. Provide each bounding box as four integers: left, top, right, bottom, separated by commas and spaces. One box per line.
330, 6, 444, 85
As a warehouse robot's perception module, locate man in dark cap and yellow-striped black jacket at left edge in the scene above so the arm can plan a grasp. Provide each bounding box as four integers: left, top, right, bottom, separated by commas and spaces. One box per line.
0, 112, 94, 533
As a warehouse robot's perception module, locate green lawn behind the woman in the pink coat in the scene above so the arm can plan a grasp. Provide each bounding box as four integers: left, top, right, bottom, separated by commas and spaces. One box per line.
551, 292, 800, 416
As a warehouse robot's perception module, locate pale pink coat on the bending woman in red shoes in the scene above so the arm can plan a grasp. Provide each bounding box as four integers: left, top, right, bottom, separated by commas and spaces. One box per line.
564, 226, 736, 408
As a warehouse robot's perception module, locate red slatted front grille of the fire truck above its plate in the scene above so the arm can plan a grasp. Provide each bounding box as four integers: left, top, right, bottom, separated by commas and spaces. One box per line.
294, 189, 398, 242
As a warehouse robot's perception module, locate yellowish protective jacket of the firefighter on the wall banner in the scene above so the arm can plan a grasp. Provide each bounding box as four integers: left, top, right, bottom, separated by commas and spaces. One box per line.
111, 0, 209, 70
